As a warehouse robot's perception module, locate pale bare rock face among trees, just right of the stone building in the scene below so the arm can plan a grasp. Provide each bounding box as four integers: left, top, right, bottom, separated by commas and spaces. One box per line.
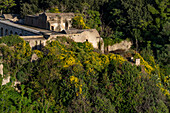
108, 40, 132, 52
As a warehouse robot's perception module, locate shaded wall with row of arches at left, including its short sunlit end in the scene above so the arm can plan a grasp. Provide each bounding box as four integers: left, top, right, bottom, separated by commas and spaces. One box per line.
0, 20, 46, 50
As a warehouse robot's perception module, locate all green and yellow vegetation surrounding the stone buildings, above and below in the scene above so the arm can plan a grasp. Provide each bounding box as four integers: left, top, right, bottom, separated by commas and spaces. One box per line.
0, 0, 170, 112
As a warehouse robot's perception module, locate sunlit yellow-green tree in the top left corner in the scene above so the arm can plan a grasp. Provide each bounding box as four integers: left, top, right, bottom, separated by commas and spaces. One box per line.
0, 0, 16, 15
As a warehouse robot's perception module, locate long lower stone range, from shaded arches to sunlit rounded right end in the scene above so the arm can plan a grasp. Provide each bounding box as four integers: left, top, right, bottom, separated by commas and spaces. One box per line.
0, 20, 104, 52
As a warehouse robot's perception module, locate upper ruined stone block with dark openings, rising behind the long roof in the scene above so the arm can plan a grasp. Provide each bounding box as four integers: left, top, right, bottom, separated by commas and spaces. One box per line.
24, 13, 74, 32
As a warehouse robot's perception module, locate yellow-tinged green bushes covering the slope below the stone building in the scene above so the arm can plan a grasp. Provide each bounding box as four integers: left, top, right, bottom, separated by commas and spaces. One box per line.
0, 36, 170, 113
